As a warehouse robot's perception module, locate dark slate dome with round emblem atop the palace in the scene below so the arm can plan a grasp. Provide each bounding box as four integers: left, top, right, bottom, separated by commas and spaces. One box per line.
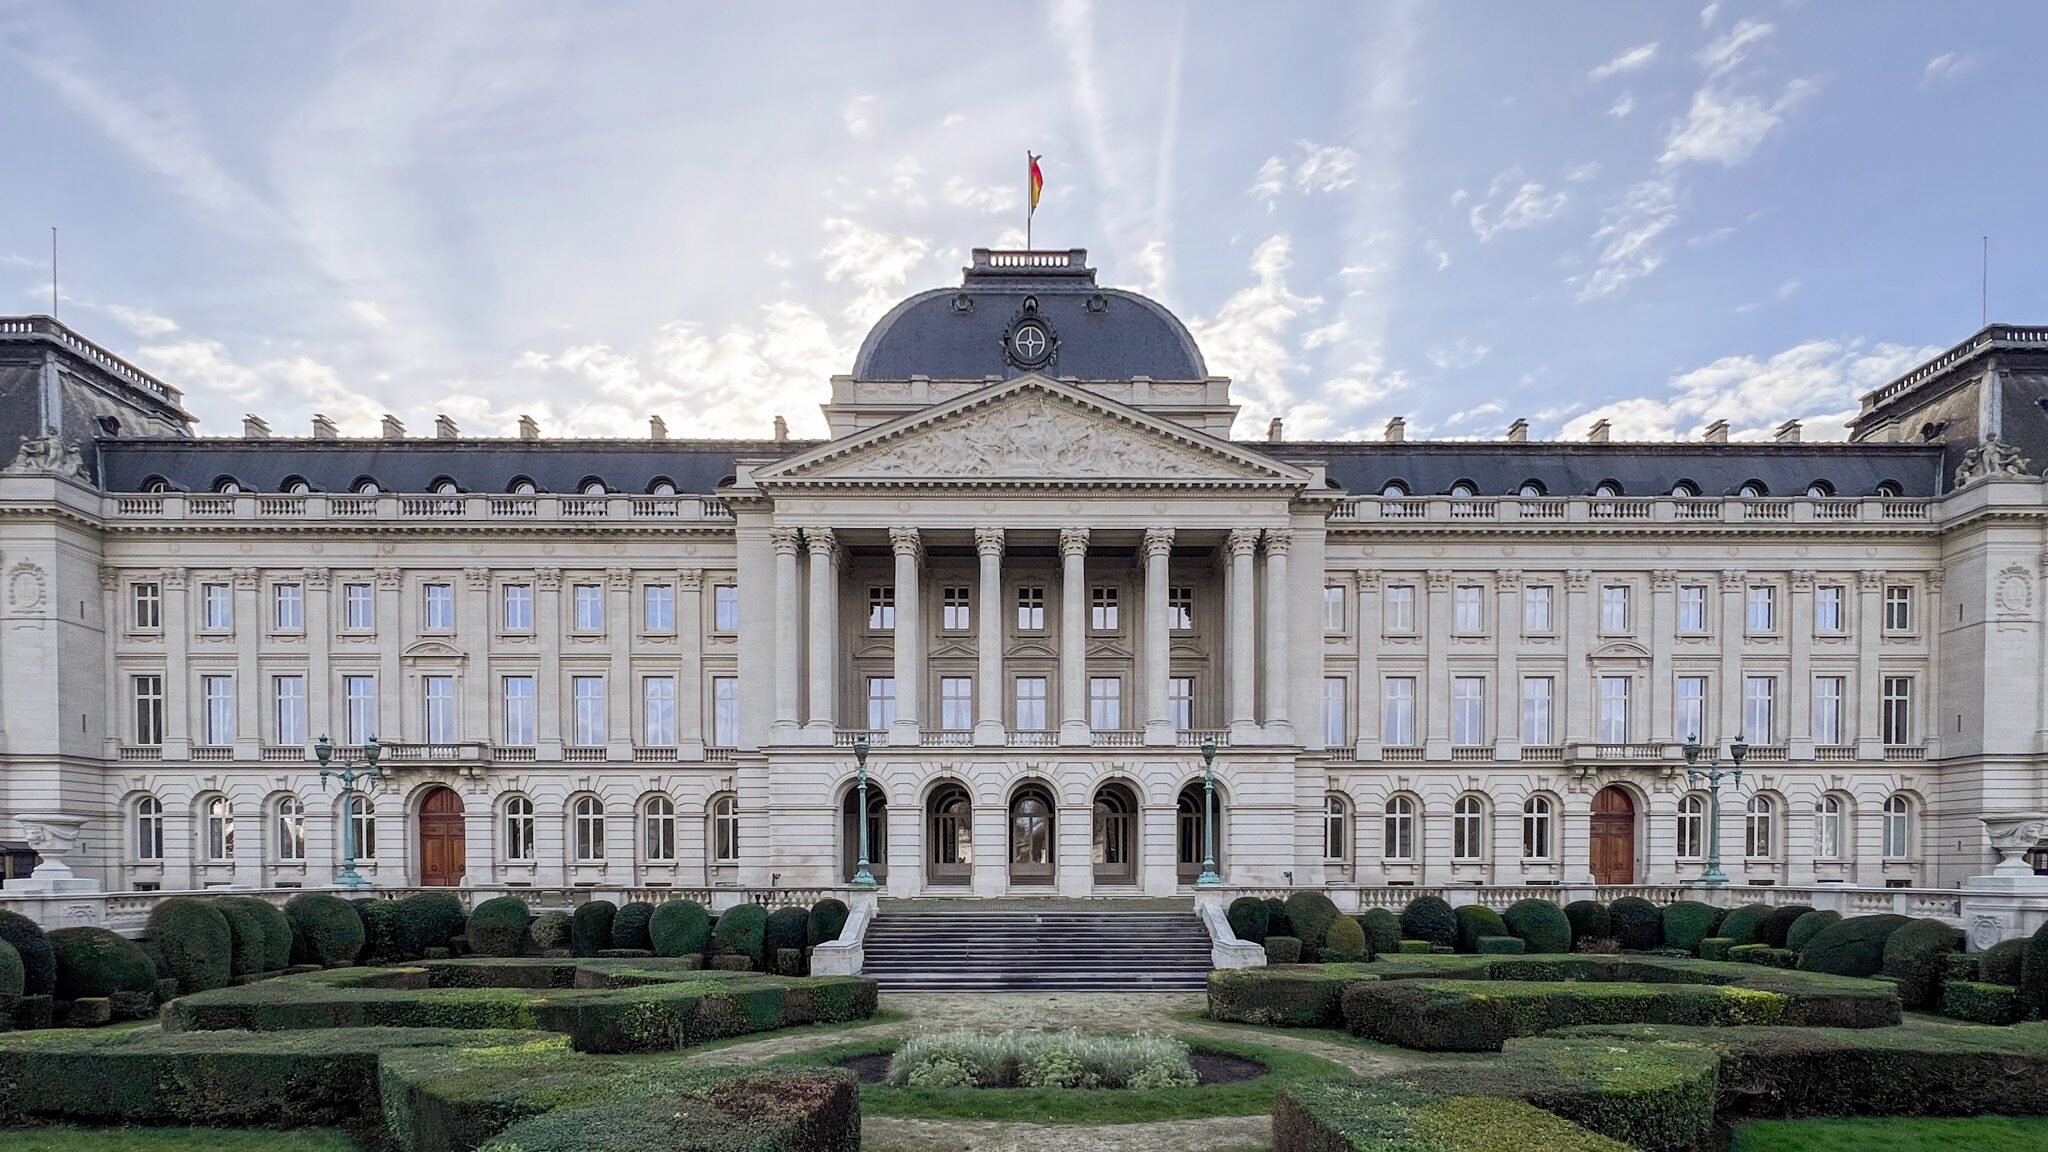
854, 248, 1208, 381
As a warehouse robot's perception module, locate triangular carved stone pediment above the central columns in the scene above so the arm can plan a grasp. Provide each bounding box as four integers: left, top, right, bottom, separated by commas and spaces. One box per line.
754, 375, 1311, 488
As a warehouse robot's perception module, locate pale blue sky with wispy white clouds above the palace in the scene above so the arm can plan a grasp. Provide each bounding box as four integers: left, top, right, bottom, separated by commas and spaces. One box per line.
0, 0, 2048, 441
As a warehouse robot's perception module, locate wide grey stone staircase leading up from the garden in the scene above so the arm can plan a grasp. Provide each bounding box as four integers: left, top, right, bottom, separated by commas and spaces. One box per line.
862, 902, 1208, 992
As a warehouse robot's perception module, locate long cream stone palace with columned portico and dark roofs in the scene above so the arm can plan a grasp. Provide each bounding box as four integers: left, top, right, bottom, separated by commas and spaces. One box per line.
0, 250, 2048, 896
